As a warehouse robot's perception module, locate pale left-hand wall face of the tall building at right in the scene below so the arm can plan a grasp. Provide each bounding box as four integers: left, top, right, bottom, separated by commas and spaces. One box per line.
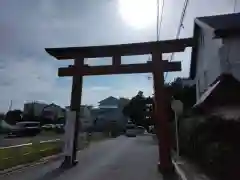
195, 30, 222, 100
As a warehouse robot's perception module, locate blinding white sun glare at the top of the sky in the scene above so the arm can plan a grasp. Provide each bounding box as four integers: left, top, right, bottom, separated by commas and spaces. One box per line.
118, 0, 157, 29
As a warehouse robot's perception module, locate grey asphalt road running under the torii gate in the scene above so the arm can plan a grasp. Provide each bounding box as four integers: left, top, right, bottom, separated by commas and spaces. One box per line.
0, 135, 176, 180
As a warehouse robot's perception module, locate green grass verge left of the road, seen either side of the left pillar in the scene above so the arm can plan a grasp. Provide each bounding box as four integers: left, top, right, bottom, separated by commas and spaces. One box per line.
0, 132, 107, 170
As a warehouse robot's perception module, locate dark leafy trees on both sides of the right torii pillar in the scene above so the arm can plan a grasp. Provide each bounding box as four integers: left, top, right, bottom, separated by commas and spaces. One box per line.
123, 78, 196, 130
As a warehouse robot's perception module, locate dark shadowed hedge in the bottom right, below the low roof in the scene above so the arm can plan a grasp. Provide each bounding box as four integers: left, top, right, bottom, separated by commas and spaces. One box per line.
179, 117, 240, 179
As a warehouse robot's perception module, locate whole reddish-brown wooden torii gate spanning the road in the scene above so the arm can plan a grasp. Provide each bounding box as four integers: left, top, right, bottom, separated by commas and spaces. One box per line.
46, 38, 192, 171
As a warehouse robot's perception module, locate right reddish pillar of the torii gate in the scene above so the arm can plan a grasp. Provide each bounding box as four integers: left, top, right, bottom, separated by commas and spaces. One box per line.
152, 51, 173, 172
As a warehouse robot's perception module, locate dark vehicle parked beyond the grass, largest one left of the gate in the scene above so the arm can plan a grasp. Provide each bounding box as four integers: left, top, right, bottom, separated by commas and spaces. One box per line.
8, 121, 41, 136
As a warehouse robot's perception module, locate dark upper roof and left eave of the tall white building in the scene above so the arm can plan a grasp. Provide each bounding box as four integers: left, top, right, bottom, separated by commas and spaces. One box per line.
190, 13, 240, 79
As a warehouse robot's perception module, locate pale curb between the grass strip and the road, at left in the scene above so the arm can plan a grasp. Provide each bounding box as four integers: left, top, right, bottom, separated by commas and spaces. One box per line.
0, 153, 64, 176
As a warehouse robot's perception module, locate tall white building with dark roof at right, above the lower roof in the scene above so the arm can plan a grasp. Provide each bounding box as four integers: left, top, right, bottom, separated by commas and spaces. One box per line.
190, 13, 240, 99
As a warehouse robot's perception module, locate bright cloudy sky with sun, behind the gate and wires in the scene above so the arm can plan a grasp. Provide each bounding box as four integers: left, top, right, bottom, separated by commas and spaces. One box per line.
0, 0, 240, 111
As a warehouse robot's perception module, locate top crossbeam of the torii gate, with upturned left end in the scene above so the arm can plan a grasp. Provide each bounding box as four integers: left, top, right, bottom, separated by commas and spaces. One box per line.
46, 38, 192, 60
